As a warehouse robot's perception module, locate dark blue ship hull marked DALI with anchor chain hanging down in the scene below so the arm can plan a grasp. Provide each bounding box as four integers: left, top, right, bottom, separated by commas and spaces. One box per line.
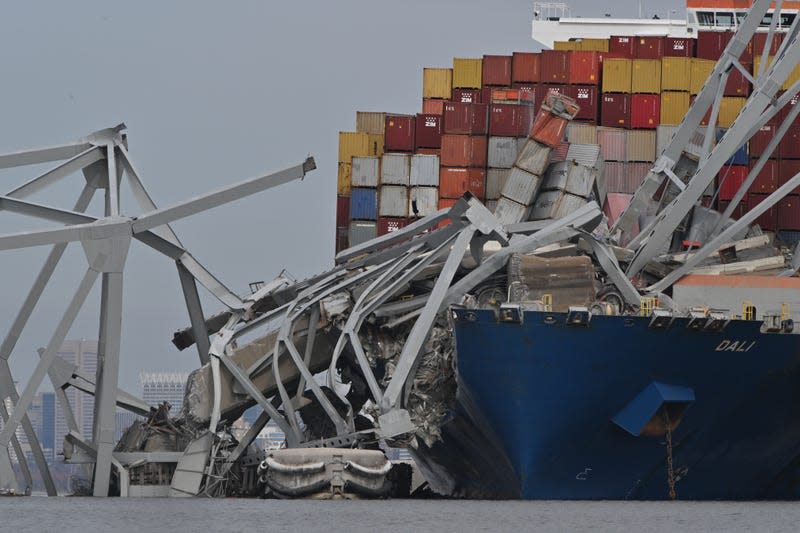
416, 309, 800, 500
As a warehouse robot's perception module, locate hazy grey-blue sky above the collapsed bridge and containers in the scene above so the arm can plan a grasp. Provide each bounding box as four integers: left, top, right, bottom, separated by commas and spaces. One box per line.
0, 0, 684, 394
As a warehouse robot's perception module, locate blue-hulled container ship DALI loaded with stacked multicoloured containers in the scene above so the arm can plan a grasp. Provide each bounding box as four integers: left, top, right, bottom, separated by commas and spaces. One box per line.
322, 0, 800, 499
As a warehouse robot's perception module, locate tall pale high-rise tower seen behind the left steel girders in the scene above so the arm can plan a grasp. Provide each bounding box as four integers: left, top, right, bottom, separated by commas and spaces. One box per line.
55, 339, 97, 454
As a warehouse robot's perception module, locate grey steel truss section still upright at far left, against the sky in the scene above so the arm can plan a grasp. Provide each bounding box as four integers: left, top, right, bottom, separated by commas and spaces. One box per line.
0, 124, 315, 496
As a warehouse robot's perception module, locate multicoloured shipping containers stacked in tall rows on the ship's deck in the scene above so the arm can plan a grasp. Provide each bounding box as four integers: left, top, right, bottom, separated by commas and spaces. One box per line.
337, 31, 800, 250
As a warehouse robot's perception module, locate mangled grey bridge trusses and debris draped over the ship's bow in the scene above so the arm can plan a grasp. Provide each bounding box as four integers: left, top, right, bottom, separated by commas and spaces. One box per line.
0, 2, 800, 497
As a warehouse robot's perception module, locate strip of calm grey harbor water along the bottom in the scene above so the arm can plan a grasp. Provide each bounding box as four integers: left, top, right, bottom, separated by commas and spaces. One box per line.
0, 496, 800, 533
